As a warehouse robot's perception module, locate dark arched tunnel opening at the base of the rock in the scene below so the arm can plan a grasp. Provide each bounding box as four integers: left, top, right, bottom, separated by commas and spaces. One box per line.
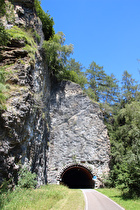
60, 165, 95, 189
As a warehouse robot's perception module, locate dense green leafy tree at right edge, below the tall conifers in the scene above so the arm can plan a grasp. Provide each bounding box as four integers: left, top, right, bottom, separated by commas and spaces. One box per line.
109, 101, 140, 195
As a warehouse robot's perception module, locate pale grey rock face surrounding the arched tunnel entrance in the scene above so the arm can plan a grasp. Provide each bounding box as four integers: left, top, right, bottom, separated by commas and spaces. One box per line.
47, 82, 110, 185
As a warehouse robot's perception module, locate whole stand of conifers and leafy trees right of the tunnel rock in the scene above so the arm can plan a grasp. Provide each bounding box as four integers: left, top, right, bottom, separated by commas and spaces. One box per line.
86, 62, 140, 197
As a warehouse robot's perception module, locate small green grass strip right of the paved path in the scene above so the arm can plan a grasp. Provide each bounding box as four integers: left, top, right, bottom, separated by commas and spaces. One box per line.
97, 188, 140, 210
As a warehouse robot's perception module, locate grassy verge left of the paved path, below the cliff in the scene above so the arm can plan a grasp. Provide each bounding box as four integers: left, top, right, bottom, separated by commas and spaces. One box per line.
0, 185, 85, 210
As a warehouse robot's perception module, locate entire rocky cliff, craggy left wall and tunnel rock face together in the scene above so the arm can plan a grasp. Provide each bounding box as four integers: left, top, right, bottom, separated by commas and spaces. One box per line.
0, 0, 109, 185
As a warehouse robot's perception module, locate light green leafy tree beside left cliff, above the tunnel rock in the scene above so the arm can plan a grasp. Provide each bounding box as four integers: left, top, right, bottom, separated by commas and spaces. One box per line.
43, 32, 73, 80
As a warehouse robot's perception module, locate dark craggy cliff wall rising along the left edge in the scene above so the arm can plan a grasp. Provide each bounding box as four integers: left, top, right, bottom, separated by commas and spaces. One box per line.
0, 0, 50, 185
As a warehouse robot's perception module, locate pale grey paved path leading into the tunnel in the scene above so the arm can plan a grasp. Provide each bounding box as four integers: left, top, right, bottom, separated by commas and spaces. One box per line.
82, 189, 124, 210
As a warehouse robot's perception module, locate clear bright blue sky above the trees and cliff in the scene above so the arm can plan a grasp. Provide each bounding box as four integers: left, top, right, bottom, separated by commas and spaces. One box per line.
41, 0, 140, 82
